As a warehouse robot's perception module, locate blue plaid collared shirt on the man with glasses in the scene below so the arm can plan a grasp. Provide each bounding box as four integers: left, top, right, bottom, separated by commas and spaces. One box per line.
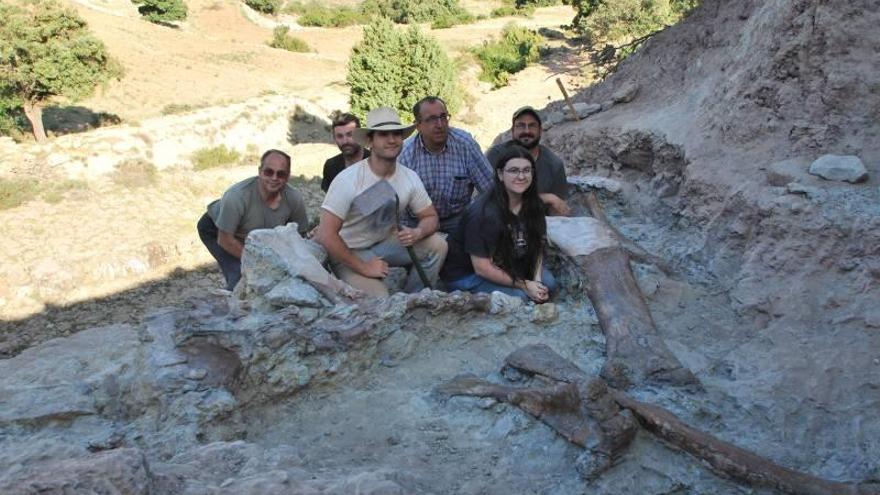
397, 127, 493, 220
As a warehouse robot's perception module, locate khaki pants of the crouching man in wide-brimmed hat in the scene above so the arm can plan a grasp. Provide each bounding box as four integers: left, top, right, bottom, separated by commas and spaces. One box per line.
330, 233, 448, 297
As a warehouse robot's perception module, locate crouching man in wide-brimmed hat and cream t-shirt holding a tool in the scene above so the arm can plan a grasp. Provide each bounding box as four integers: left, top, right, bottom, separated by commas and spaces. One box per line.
315, 107, 447, 297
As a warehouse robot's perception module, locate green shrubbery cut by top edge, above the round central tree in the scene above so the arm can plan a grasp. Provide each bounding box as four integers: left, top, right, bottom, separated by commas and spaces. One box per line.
361, 0, 474, 25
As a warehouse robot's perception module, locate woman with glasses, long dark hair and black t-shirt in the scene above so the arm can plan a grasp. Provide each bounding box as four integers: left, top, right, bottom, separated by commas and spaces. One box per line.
441, 146, 556, 303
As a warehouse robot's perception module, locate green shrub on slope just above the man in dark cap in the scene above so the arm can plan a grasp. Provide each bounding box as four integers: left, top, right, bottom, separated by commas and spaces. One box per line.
473, 24, 544, 88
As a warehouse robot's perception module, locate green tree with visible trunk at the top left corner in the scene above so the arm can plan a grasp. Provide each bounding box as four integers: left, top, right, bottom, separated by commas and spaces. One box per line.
0, 0, 122, 141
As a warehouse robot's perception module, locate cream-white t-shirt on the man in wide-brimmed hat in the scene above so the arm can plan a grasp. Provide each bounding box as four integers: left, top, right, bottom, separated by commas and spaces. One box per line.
321, 158, 431, 249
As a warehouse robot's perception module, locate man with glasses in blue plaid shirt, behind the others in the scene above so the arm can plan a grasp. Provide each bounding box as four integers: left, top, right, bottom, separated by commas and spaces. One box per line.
397, 96, 492, 233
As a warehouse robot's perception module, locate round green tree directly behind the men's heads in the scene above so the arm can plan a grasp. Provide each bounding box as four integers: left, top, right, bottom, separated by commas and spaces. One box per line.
346, 18, 462, 120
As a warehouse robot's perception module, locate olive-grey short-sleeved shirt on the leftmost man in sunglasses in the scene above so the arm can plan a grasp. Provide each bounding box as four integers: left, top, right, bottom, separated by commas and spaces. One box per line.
208, 177, 309, 242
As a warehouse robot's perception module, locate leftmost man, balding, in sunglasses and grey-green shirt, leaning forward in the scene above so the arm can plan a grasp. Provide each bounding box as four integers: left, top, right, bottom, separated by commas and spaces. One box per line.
198, 150, 309, 290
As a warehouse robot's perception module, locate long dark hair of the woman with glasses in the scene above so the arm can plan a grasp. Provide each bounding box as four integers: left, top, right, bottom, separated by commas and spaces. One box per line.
487, 145, 547, 280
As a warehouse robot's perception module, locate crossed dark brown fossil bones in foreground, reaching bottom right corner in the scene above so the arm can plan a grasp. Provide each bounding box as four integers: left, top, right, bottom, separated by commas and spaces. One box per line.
440, 344, 880, 495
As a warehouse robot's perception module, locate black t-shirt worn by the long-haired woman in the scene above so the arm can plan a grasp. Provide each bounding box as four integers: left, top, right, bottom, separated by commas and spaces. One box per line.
440, 190, 531, 282
